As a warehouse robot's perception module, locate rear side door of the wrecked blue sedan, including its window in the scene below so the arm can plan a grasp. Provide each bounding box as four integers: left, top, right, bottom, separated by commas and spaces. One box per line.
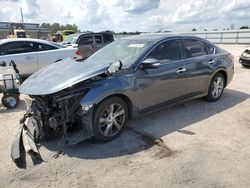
183, 39, 213, 97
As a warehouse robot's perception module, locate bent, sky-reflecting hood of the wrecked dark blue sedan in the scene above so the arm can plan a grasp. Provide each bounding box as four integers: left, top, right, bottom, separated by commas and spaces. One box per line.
19, 58, 109, 95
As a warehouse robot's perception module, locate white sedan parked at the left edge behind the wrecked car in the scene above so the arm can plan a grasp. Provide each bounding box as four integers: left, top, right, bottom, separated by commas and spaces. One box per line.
0, 38, 81, 77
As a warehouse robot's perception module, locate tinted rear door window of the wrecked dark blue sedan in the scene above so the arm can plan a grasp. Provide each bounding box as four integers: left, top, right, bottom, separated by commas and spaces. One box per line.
183, 39, 207, 58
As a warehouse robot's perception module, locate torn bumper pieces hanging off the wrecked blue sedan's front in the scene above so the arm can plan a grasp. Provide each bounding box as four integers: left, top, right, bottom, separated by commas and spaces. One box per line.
11, 109, 93, 168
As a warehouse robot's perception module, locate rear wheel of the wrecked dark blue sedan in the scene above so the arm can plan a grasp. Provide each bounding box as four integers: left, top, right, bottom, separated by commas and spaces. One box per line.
205, 72, 226, 102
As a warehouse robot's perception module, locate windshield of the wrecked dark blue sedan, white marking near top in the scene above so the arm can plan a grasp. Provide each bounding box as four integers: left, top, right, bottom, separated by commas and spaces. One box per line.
85, 39, 151, 68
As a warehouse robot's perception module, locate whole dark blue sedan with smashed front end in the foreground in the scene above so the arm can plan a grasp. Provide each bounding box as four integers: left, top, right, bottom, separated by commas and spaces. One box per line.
11, 34, 234, 167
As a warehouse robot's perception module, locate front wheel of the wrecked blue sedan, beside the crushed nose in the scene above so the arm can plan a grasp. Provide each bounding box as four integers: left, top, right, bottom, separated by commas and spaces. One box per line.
93, 97, 128, 142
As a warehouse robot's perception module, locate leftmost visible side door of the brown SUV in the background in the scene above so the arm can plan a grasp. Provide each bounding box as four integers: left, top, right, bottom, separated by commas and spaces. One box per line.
77, 35, 95, 59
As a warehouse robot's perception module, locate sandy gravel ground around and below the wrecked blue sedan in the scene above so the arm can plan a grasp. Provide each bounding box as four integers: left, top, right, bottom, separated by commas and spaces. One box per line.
0, 45, 250, 187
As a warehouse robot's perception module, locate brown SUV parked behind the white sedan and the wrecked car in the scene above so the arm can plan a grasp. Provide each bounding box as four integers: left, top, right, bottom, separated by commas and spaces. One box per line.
63, 32, 114, 59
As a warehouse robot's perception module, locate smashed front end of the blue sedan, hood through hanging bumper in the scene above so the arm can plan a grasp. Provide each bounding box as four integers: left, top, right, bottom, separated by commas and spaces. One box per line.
11, 60, 122, 168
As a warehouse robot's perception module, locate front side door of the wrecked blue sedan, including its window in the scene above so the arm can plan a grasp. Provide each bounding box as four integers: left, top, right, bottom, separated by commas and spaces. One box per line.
136, 39, 187, 112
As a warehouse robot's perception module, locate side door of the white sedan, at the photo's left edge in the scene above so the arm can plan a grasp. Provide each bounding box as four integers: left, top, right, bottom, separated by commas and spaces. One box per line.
0, 41, 38, 77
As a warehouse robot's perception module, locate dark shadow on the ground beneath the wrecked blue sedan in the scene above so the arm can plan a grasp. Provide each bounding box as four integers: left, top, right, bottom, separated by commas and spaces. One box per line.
41, 89, 250, 159
